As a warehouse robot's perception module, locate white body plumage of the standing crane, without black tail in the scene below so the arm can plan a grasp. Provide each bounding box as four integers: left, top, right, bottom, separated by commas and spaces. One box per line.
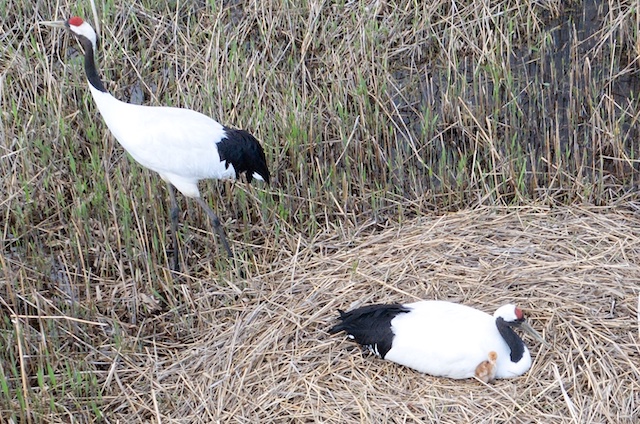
89, 84, 242, 197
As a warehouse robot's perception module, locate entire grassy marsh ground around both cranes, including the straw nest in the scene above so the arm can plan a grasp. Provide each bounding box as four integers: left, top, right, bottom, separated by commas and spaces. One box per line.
0, 0, 640, 423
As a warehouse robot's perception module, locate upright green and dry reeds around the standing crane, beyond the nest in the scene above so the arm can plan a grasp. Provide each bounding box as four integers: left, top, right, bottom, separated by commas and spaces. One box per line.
0, 0, 640, 421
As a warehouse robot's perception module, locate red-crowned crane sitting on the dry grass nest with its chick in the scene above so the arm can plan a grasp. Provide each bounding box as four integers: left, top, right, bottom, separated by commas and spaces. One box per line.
329, 300, 546, 382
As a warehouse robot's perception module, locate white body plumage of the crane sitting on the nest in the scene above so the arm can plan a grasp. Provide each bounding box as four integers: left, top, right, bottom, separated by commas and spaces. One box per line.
385, 300, 531, 379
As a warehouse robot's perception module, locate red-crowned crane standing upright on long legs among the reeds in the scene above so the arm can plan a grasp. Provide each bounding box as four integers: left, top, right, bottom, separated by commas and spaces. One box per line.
41, 16, 269, 271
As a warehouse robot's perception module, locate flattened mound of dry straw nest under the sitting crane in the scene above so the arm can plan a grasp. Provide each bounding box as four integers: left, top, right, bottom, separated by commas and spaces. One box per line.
84, 207, 640, 423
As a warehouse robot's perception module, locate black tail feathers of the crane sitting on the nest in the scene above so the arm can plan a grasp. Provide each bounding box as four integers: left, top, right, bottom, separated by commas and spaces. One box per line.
329, 304, 411, 358
